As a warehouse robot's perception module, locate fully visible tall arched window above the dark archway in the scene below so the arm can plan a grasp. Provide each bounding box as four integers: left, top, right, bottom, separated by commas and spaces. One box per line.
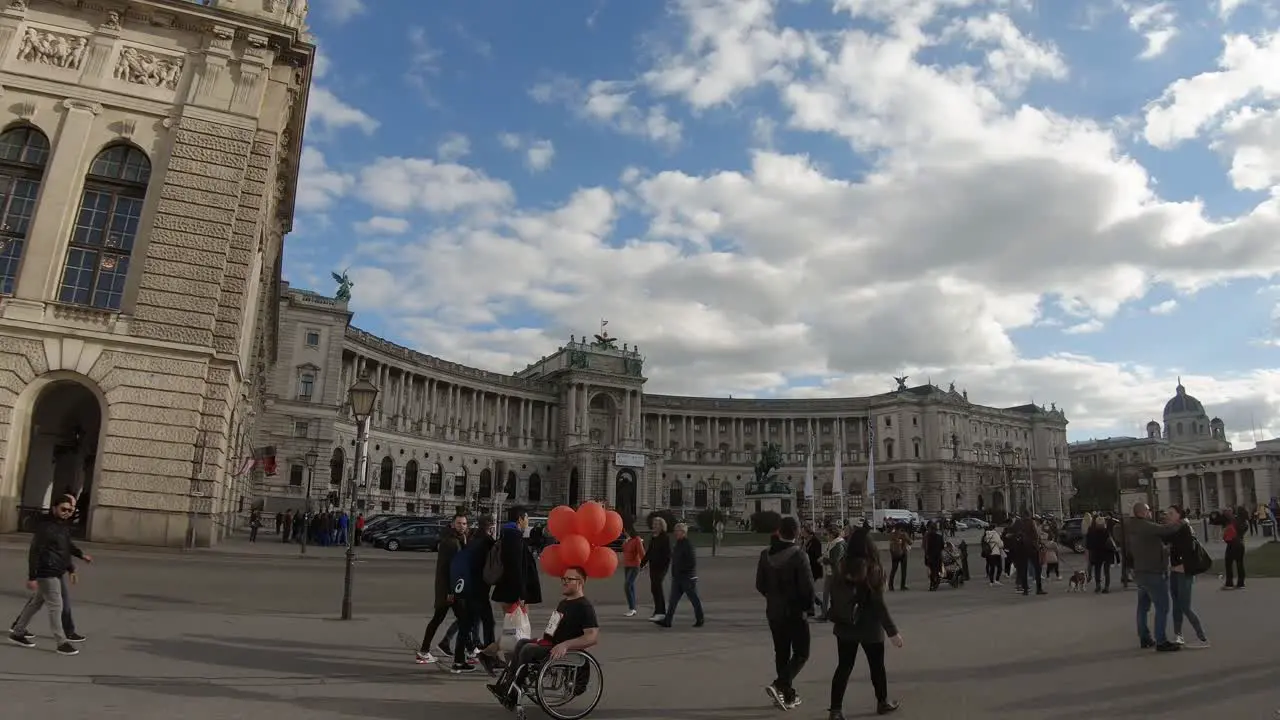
58, 145, 151, 310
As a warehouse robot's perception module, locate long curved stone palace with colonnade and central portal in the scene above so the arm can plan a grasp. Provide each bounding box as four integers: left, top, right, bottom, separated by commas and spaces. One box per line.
256, 283, 1071, 515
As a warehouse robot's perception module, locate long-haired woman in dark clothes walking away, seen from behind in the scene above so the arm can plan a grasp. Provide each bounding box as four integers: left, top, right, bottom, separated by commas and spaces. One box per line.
828, 532, 902, 720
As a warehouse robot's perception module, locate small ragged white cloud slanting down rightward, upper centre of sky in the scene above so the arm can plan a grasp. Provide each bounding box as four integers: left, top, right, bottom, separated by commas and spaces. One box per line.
529, 79, 682, 146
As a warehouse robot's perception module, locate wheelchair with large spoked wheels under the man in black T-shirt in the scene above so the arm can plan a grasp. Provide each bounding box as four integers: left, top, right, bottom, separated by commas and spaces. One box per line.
513, 650, 604, 720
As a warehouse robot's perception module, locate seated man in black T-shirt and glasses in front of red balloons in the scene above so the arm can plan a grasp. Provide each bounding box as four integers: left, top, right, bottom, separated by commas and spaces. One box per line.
489, 568, 600, 707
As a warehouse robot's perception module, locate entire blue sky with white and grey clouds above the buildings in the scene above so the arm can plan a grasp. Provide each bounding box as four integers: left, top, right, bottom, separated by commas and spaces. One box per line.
293, 0, 1280, 447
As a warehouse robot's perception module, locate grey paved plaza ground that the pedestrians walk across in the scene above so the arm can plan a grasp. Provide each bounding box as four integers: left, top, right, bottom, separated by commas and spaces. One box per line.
0, 541, 1280, 720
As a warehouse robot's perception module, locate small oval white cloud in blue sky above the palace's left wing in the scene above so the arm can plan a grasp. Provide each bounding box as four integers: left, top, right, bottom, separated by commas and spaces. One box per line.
358, 158, 515, 213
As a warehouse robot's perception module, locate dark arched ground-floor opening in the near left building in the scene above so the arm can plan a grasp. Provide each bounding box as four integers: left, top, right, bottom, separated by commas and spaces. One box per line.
18, 378, 104, 538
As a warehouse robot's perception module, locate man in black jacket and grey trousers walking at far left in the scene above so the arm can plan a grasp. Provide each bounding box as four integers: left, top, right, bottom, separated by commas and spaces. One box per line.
9, 497, 92, 655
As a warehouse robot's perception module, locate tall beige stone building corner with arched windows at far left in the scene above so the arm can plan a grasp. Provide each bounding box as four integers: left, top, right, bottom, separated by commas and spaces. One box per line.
0, 0, 314, 544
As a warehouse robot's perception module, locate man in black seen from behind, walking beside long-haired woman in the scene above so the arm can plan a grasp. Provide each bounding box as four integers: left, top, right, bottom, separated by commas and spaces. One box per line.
755, 518, 814, 710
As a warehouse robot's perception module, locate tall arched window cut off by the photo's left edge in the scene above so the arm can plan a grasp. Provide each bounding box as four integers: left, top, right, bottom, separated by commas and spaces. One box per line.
0, 126, 49, 295
